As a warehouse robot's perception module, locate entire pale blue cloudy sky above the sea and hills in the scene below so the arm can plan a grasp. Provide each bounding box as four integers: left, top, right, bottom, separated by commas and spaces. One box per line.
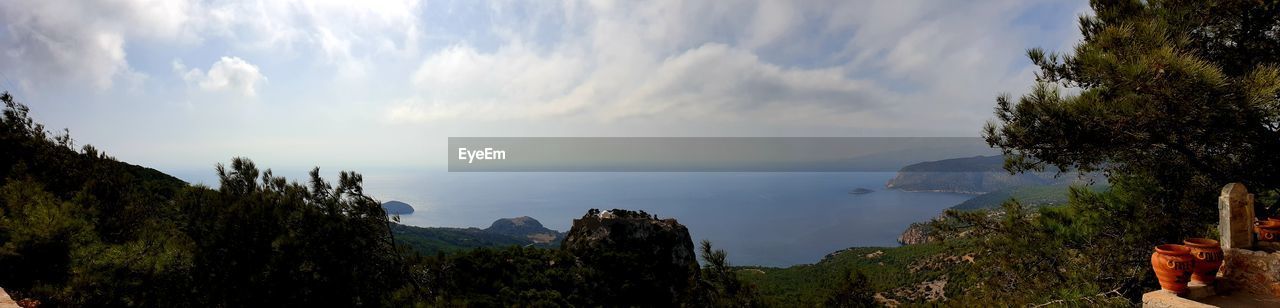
0, 0, 1088, 174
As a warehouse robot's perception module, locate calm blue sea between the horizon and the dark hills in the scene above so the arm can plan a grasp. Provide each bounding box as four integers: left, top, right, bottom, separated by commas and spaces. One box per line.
365, 171, 973, 266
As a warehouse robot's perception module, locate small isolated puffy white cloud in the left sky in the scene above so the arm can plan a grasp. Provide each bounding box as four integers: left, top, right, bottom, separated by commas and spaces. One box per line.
173, 56, 266, 97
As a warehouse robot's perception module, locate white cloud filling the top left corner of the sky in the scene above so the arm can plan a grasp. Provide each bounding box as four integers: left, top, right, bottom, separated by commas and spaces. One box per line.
0, 0, 191, 89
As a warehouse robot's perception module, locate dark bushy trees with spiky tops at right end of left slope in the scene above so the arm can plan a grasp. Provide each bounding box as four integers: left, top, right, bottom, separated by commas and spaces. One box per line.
175, 158, 404, 305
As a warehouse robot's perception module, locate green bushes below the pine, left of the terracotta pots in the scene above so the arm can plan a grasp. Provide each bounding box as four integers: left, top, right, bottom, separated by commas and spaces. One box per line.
934, 178, 1180, 305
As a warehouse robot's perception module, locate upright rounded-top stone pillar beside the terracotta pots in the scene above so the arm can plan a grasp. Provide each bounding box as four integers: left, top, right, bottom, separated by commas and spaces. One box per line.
1217, 183, 1254, 250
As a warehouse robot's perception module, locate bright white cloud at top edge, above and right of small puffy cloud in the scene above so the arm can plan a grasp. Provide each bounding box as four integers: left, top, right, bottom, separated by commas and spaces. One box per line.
200, 0, 421, 78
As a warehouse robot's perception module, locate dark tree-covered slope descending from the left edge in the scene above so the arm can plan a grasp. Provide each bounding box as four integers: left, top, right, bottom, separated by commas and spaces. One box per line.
0, 93, 407, 307
